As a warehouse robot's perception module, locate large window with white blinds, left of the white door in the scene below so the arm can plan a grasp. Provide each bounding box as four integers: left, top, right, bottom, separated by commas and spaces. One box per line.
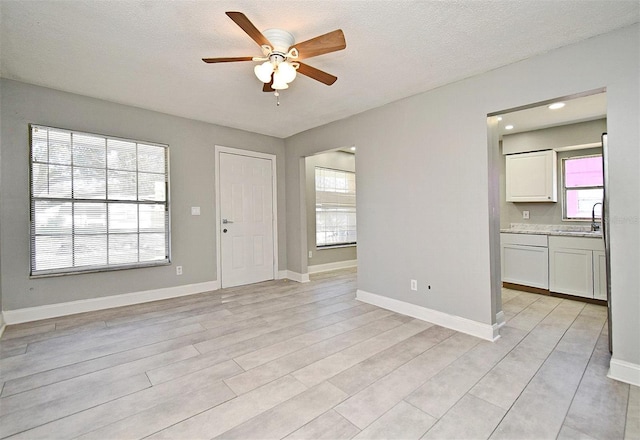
31, 125, 169, 275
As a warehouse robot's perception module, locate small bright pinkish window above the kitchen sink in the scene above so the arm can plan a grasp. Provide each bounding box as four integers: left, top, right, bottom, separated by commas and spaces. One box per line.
562, 155, 603, 220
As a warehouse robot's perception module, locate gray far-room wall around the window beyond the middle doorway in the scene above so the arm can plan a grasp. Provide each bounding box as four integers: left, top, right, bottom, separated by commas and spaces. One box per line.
305, 151, 357, 266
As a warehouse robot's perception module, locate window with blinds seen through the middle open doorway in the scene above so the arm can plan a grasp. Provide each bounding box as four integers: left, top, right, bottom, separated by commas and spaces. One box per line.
316, 167, 356, 247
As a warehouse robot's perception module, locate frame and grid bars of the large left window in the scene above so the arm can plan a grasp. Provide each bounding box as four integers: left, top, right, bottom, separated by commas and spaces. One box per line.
29, 123, 171, 278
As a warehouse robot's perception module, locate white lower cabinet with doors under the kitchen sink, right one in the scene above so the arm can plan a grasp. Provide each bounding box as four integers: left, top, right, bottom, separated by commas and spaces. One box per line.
549, 236, 606, 299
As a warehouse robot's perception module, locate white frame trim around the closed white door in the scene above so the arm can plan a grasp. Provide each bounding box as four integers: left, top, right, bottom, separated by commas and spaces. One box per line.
215, 145, 278, 288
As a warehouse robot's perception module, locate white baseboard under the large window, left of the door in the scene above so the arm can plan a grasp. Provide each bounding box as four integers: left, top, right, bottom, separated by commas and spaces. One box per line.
2, 280, 220, 325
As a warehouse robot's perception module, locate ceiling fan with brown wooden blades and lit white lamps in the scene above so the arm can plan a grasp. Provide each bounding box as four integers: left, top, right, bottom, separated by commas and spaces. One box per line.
202, 12, 347, 101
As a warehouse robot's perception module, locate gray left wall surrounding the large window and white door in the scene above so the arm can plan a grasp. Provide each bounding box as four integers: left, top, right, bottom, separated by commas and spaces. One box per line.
0, 80, 287, 310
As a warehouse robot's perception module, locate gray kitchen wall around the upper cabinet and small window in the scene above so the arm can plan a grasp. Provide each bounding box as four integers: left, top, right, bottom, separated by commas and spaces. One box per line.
500, 119, 607, 228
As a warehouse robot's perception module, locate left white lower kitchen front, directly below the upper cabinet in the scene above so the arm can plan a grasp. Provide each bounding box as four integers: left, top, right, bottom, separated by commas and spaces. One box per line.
500, 233, 549, 290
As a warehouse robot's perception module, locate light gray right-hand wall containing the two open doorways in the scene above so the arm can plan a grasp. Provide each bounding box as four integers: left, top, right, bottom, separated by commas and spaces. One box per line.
286, 24, 640, 364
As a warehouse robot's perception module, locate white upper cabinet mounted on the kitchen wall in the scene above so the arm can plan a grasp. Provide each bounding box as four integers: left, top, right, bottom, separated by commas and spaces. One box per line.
505, 150, 558, 202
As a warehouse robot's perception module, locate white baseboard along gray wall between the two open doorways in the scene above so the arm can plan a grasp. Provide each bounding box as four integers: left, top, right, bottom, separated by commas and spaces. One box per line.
356, 289, 500, 341
